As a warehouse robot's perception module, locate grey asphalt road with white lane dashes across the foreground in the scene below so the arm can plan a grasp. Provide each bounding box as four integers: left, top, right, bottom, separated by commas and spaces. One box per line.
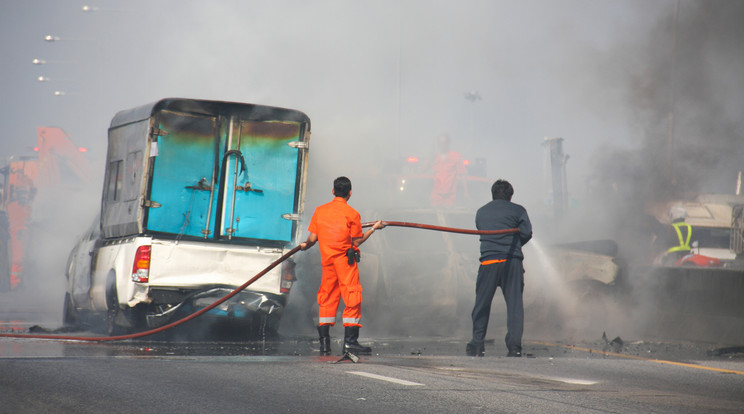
0, 325, 744, 413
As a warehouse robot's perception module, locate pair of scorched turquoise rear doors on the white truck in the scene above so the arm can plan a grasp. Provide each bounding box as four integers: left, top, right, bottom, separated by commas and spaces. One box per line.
147, 112, 302, 244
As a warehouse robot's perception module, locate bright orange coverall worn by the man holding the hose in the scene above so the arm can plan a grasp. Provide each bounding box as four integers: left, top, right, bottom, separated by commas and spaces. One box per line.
308, 197, 364, 327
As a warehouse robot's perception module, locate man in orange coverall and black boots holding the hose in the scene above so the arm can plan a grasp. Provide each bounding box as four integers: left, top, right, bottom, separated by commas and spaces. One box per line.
300, 177, 385, 355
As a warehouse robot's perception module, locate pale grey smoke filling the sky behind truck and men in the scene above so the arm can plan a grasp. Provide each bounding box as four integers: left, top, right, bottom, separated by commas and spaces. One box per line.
0, 0, 744, 342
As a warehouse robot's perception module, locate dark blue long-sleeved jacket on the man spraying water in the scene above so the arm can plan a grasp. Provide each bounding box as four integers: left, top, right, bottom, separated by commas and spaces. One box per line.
475, 199, 532, 262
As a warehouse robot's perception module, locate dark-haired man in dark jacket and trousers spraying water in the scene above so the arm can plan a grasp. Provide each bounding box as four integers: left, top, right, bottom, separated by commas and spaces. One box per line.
465, 180, 532, 357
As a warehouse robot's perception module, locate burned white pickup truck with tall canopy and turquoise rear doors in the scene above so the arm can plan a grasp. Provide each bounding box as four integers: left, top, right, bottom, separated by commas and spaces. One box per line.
63, 98, 310, 335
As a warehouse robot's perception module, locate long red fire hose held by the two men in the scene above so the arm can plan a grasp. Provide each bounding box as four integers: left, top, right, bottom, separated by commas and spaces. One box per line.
0, 221, 519, 342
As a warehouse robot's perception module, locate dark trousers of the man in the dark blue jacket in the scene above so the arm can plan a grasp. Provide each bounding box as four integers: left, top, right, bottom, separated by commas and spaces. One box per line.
472, 259, 524, 350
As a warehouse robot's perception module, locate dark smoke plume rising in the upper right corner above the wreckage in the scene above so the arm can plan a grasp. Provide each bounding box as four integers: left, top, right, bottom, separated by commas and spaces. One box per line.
589, 1, 744, 225
